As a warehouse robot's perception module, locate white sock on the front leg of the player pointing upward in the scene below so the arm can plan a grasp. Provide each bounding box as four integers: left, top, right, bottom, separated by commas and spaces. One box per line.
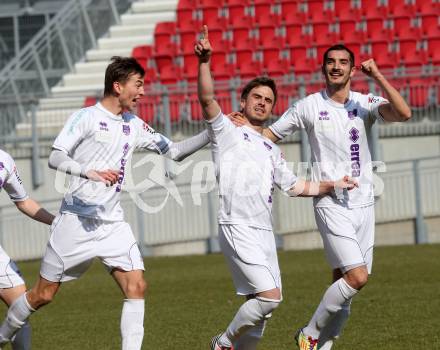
218, 297, 280, 347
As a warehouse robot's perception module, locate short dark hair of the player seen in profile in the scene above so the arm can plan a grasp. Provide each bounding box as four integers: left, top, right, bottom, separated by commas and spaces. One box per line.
104, 56, 145, 96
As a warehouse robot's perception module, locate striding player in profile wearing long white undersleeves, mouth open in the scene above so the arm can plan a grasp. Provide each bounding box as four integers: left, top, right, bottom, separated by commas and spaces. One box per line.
0, 57, 209, 350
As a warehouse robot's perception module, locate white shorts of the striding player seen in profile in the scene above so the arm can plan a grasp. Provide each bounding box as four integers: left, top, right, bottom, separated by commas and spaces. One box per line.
40, 214, 144, 282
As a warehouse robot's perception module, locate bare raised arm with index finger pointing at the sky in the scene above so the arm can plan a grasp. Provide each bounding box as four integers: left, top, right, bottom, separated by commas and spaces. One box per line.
194, 25, 220, 120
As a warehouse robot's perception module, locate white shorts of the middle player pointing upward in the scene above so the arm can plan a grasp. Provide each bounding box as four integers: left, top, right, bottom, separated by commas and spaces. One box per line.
219, 224, 281, 295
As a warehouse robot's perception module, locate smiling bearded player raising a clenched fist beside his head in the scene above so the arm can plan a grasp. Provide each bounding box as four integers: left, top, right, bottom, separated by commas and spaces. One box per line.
232, 45, 411, 350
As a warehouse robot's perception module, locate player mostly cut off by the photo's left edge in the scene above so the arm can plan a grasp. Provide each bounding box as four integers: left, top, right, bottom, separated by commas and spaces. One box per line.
0, 150, 55, 350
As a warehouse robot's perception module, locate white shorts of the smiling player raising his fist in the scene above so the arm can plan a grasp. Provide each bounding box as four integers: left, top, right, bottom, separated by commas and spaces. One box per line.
315, 205, 375, 273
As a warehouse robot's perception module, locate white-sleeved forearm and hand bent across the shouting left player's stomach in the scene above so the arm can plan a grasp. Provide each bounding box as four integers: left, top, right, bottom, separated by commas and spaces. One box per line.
49, 149, 119, 186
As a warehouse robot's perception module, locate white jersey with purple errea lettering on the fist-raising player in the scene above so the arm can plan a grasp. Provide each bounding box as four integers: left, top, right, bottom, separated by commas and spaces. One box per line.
270, 90, 388, 208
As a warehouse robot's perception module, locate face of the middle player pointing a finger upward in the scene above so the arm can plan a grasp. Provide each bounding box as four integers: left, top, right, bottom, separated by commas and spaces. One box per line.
240, 85, 275, 125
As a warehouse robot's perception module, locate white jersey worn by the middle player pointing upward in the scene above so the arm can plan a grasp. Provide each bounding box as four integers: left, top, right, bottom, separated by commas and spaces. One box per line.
207, 113, 296, 230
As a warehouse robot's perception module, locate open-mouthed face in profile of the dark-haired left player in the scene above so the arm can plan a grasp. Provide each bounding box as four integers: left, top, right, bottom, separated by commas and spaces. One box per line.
113, 73, 144, 111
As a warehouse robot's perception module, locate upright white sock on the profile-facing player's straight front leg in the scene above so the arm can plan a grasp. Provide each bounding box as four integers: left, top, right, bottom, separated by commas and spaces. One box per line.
121, 299, 145, 350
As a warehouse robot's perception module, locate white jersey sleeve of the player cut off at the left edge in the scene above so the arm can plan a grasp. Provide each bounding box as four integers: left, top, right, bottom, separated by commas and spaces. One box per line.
0, 150, 28, 202
